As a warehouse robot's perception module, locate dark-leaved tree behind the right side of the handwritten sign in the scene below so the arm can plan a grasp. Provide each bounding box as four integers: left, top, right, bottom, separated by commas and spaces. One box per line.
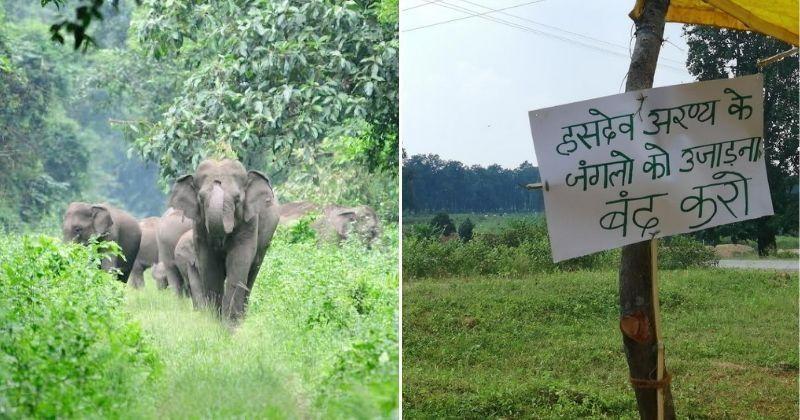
684, 25, 799, 255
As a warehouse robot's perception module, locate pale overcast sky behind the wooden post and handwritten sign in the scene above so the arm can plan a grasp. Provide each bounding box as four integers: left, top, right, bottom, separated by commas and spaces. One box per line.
400, 0, 693, 167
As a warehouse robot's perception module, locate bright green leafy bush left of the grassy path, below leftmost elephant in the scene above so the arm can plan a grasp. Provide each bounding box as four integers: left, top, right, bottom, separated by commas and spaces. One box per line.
0, 236, 157, 418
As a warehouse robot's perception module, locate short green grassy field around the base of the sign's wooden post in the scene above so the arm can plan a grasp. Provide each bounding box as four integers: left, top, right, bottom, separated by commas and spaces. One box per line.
403, 269, 798, 419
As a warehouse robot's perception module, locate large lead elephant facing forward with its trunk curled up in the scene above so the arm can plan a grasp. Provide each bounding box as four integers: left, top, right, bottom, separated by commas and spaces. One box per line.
170, 159, 280, 320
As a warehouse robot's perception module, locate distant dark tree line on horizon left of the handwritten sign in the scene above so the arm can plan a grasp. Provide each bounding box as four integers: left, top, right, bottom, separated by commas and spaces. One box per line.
403, 155, 544, 213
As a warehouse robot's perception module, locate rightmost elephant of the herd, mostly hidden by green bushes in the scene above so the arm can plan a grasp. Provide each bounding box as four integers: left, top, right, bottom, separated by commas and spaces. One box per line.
313, 204, 381, 245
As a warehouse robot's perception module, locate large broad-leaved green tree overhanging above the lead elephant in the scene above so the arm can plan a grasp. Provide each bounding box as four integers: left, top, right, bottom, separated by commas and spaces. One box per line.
129, 0, 398, 179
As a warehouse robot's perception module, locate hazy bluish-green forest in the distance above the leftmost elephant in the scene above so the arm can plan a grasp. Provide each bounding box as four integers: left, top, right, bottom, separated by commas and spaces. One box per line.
0, 0, 164, 230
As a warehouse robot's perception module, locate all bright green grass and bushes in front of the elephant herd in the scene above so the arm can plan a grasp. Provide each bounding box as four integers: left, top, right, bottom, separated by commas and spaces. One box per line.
0, 226, 399, 419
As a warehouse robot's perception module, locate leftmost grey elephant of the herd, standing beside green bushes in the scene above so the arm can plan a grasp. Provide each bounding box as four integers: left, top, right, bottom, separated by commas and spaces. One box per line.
61, 202, 142, 283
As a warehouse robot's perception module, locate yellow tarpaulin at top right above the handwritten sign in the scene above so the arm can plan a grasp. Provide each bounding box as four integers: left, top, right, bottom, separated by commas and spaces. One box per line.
631, 0, 798, 45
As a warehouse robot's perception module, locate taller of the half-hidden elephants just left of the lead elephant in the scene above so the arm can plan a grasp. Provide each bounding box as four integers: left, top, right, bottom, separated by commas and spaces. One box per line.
153, 208, 194, 296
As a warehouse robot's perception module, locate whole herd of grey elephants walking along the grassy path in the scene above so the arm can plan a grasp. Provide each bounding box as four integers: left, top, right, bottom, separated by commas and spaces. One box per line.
62, 159, 380, 320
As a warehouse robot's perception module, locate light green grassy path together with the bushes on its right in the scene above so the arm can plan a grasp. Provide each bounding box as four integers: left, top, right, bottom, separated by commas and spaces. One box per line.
127, 226, 399, 419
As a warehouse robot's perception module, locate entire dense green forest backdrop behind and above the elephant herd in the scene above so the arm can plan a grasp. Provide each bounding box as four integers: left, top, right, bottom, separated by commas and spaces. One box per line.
0, 0, 398, 230
